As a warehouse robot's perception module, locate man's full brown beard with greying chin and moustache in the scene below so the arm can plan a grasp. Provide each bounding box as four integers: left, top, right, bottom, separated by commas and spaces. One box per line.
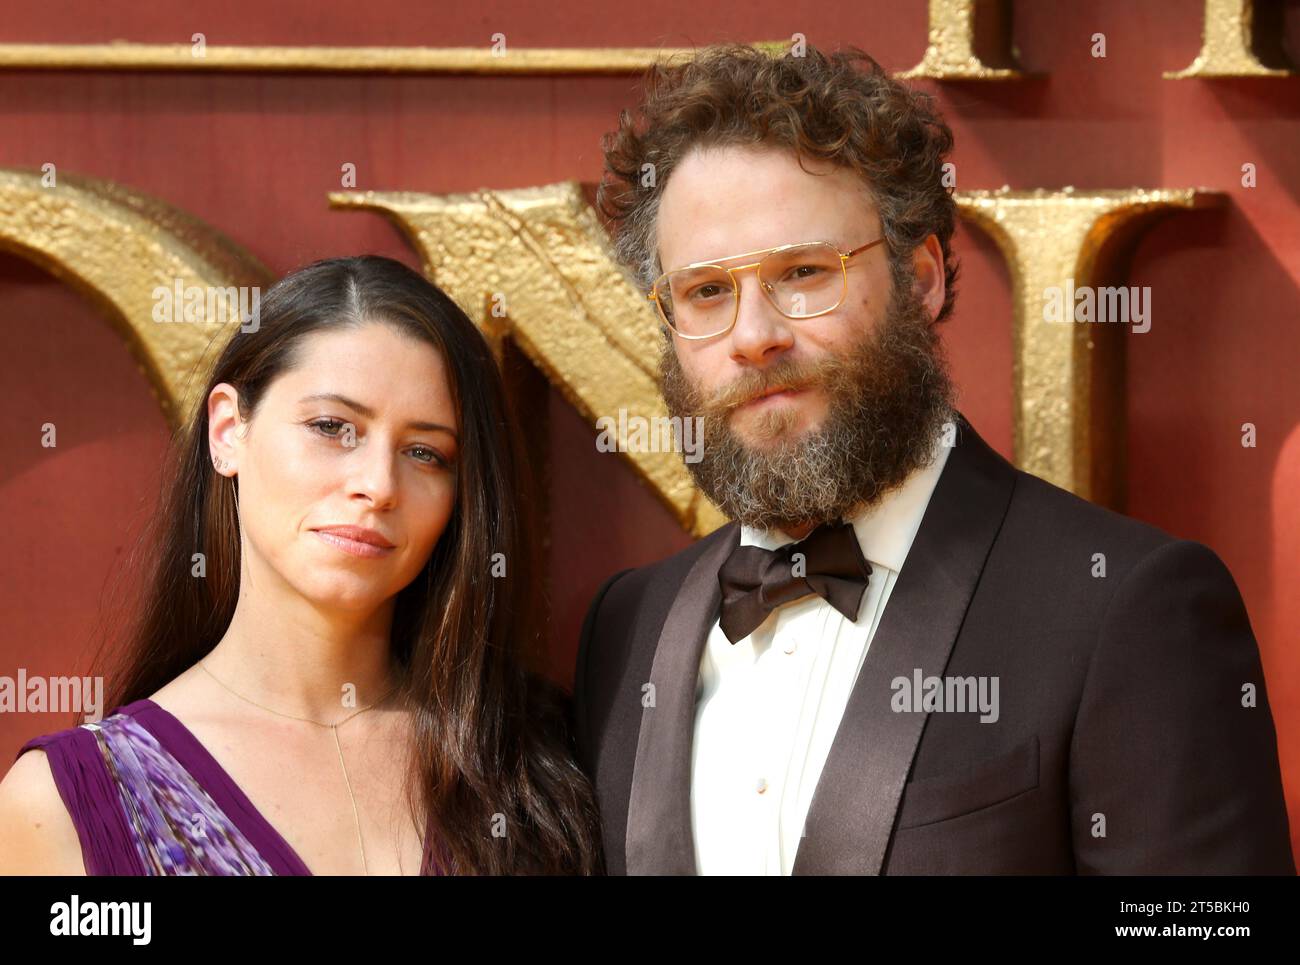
659, 277, 953, 531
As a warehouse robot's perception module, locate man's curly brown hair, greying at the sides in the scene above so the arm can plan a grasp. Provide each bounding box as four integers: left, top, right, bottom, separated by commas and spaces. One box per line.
595, 43, 958, 321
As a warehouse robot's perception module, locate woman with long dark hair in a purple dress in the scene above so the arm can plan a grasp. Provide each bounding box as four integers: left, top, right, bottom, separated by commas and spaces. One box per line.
0, 256, 599, 874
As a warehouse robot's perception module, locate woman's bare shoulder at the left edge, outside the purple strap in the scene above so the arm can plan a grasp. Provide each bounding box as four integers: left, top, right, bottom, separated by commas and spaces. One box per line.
0, 732, 86, 875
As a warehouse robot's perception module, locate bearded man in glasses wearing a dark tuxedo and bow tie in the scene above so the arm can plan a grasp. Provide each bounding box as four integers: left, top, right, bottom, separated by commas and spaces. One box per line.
575, 46, 1295, 874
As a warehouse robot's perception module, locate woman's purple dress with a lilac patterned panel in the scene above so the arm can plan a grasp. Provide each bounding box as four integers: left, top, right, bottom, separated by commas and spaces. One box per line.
18, 698, 436, 875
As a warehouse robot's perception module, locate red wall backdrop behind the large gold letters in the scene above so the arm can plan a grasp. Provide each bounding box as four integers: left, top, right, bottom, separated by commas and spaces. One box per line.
0, 0, 1300, 863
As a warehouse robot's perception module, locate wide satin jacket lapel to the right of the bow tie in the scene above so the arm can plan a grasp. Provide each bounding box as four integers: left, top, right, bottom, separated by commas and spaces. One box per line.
793, 419, 1015, 874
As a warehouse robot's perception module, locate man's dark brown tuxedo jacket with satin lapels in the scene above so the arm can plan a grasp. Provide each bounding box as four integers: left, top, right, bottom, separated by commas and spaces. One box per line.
573, 419, 1295, 874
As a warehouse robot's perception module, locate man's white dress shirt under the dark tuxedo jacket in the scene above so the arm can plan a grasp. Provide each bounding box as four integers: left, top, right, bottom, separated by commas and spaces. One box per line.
690, 441, 949, 874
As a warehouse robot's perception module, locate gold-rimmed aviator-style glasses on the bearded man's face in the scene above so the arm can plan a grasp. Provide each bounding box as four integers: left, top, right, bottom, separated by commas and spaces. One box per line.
646, 238, 884, 338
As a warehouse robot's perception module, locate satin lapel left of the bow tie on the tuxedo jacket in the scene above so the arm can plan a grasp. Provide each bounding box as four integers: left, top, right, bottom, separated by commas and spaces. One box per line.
627, 524, 740, 874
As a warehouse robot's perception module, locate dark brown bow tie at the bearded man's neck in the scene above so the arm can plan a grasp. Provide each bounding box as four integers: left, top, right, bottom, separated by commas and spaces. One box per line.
718, 523, 871, 644
